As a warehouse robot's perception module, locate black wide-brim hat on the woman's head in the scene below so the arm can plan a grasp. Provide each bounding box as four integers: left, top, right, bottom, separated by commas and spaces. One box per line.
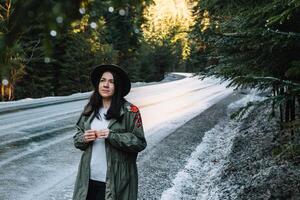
91, 64, 131, 97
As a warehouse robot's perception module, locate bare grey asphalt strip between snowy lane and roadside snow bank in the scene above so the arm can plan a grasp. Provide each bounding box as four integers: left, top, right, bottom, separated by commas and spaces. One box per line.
138, 93, 242, 200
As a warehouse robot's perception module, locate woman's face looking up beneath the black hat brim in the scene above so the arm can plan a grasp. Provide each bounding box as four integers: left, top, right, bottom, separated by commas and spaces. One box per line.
99, 72, 115, 99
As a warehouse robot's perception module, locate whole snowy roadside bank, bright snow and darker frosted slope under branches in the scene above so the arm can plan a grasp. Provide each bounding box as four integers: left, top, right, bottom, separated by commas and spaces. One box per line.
161, 91, 300, 200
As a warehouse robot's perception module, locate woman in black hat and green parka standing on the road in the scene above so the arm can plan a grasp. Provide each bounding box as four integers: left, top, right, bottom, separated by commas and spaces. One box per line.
73, 65, 147, 200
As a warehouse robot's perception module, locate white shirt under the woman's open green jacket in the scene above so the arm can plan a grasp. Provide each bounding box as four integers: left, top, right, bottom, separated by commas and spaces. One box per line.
90, 108, 109, 182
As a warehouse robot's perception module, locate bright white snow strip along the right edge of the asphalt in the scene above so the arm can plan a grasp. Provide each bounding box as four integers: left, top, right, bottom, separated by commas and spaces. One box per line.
161, 90, 263, 200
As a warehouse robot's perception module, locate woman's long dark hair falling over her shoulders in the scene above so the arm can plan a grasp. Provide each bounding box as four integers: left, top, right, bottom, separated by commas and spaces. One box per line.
83, 71, 125, 121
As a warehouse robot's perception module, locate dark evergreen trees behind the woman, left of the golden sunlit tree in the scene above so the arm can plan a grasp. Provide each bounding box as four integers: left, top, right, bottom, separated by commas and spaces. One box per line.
0, 0, 176, 100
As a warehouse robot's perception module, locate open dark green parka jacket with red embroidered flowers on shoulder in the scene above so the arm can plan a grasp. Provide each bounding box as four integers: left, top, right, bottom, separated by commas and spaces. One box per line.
73, 102, 147, 200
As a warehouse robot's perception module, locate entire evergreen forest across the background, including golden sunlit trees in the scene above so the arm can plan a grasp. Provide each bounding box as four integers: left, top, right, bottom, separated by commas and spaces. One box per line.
0, 0, 300, 158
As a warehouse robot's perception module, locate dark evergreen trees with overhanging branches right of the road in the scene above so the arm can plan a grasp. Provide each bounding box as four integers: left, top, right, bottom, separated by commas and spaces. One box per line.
189, 0, 300, 158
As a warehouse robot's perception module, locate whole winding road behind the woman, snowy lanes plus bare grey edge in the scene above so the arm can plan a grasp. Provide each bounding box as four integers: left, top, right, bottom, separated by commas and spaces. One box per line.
0, 75, 239, 200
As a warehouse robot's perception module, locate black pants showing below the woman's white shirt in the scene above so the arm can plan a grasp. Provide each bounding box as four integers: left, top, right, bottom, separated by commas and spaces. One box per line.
86, 179, 105, 200
